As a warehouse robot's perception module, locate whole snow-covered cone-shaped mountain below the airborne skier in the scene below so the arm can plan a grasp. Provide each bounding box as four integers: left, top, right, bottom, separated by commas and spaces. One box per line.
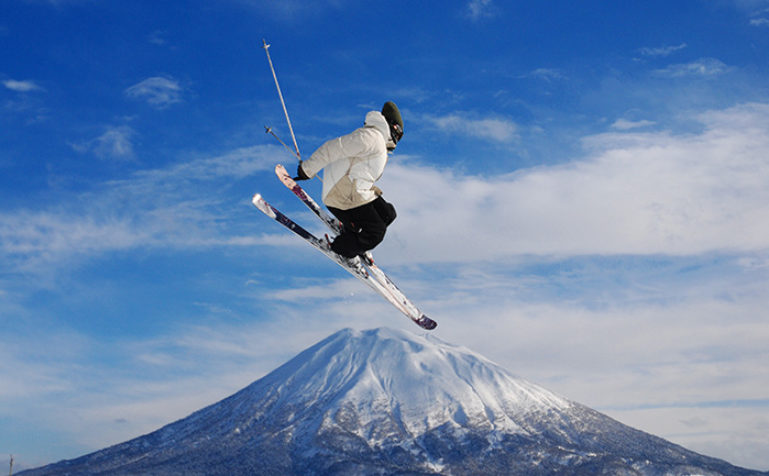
23, 329, 767, 476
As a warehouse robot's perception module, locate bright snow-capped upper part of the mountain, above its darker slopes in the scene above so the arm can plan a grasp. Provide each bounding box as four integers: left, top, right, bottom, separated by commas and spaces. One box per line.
275, 328, 571, 435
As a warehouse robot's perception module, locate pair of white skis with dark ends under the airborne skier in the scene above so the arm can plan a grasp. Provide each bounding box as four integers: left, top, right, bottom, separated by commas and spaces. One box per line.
252, 164, 438, 330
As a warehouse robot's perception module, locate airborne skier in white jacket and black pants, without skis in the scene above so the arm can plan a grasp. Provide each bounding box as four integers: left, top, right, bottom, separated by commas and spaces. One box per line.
294, 101, 403, 258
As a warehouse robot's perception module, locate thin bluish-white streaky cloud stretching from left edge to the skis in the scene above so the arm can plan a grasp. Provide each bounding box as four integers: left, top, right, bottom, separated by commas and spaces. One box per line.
0, 140, 283, 274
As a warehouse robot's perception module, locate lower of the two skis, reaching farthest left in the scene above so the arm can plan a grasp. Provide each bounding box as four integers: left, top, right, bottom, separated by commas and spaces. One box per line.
252, 193, 437, 330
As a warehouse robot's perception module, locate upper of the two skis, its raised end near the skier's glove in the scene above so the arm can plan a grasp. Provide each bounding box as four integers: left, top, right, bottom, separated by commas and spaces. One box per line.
275, 164, 438, 330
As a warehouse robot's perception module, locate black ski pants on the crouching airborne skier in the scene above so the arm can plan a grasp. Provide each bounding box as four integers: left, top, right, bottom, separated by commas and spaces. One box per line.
328, 197, 397, 258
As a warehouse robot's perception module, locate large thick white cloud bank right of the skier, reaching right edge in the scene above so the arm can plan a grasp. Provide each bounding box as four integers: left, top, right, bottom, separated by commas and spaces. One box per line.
381, 104, 769, 262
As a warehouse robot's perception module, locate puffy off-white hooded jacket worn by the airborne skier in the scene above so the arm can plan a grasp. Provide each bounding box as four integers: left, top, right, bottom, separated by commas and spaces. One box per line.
302, 111, 390, 210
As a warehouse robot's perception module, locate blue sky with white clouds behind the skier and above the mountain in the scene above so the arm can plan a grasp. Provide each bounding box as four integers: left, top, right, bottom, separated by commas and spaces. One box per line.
0, 0, 769, 470
